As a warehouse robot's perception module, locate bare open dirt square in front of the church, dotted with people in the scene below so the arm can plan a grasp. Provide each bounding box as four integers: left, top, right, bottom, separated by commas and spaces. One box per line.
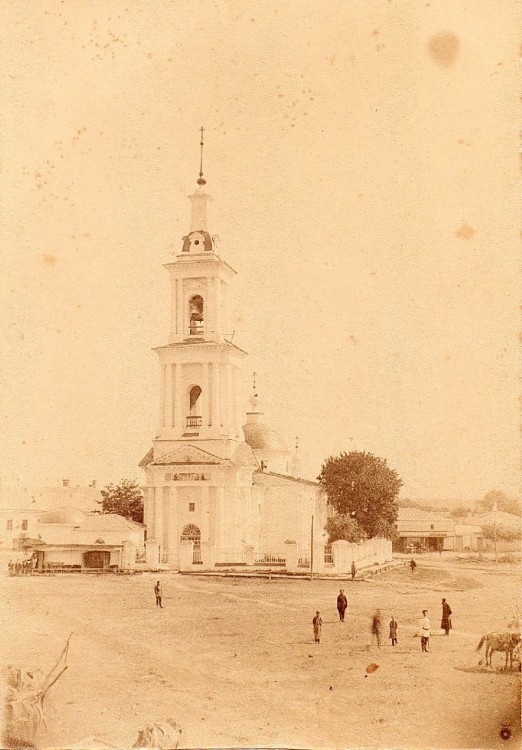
1, 559, 520, 748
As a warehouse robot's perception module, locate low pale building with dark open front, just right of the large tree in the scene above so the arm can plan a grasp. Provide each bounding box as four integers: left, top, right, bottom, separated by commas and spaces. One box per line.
394, 508, 454, 552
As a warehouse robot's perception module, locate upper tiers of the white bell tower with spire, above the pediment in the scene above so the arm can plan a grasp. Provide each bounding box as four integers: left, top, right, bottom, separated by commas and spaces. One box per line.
149, 128, 246, 458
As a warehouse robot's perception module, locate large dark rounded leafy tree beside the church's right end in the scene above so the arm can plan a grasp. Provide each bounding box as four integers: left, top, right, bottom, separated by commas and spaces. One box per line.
318, 451, 402, 539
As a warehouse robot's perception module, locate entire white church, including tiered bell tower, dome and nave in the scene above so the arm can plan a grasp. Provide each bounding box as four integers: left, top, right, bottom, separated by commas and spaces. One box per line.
140, 144, 327, 570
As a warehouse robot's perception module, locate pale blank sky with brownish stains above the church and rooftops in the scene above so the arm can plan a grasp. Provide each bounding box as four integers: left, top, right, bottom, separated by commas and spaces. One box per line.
0, 0, 520, 499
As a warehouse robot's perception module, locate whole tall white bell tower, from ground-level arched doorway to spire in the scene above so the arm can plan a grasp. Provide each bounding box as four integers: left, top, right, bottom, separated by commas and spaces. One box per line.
140, 129, 258, 569
